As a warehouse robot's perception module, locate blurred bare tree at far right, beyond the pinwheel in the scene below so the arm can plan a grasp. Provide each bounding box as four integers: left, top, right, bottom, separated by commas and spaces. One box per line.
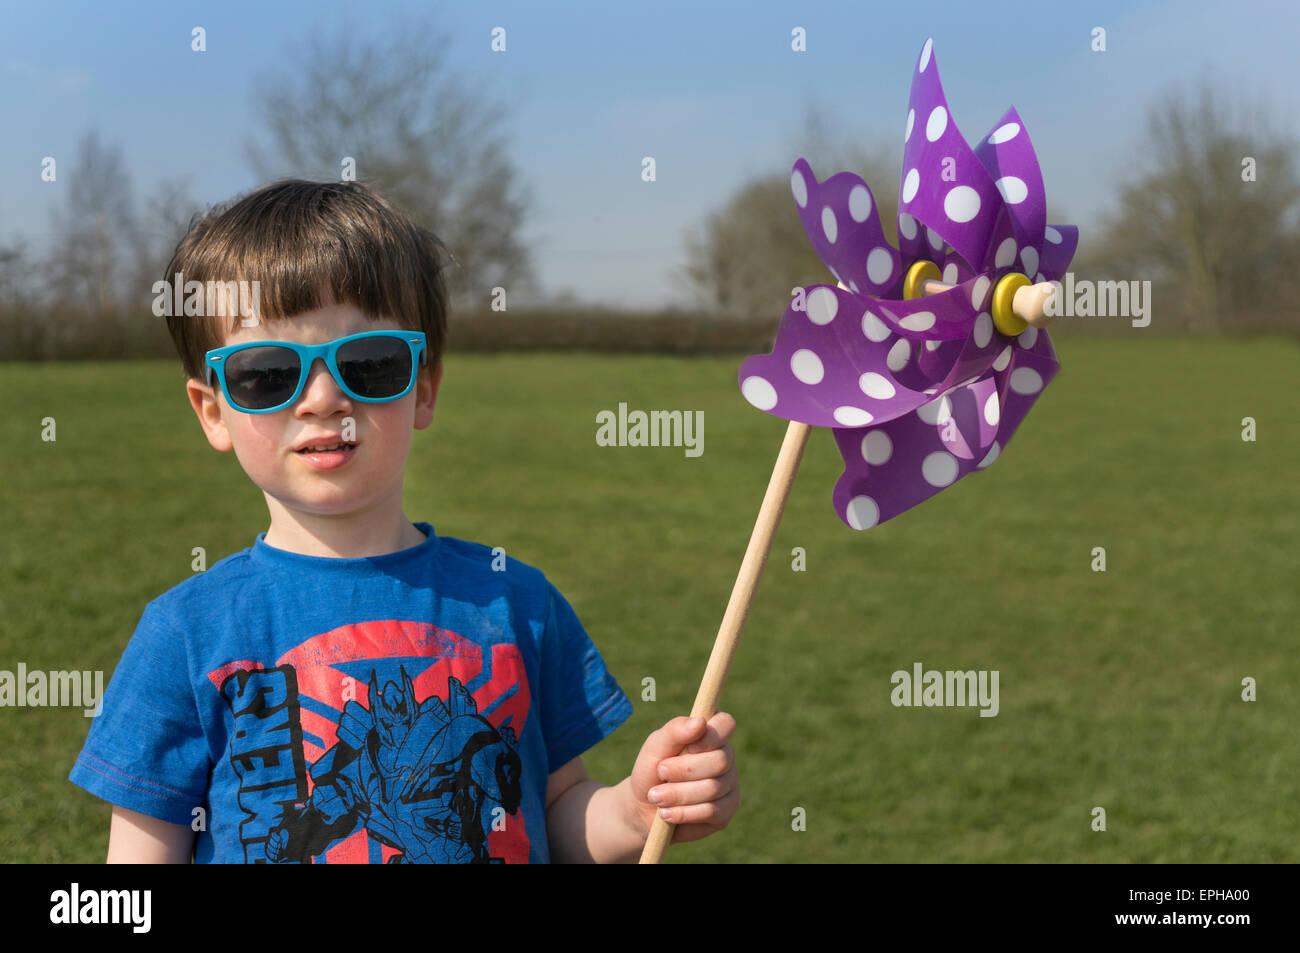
1095, 83, 1300, 330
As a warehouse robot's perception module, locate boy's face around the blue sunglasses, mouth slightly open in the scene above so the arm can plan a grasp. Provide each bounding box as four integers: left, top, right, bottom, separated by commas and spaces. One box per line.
186, 297, 442, 528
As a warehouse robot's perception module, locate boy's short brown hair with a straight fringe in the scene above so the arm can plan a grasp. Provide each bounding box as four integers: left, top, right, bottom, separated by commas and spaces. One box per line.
164, 179, 455, 380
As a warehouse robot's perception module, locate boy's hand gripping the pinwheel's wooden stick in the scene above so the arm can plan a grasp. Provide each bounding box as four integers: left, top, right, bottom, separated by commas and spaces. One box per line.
628, 711, 740, 844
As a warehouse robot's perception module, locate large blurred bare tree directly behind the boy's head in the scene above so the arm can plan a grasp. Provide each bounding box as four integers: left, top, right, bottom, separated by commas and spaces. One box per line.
250, 14, 536, 307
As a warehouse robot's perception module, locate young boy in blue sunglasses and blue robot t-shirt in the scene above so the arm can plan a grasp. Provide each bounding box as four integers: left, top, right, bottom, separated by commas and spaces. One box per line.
69, 181, 740, 863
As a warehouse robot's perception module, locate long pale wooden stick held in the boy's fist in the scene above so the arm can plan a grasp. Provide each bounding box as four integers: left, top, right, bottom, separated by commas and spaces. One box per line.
641, 420, 813, 863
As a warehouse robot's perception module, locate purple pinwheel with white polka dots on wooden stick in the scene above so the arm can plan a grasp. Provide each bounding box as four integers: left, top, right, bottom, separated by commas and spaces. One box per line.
641, 39, 1079, 863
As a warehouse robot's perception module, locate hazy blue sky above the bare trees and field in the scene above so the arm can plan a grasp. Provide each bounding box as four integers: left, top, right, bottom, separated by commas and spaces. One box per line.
0, 0, 1300, 308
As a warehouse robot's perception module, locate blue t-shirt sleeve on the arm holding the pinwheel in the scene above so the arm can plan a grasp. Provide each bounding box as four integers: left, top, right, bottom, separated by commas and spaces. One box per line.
541, 582, 632, 772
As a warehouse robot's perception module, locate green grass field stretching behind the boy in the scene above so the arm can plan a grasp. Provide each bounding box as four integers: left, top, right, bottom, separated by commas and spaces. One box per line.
0, 338, 1300, 862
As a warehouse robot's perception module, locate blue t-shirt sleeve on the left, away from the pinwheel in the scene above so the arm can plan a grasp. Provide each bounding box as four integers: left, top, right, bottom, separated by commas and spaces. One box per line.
68, 601, 211, 824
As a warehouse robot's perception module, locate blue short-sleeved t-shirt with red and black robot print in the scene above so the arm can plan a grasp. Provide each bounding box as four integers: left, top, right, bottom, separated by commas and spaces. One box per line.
69, 523, 632, 863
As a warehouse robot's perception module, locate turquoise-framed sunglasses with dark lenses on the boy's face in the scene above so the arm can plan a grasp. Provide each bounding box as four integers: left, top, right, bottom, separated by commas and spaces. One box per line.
207, 330, 426, 413
